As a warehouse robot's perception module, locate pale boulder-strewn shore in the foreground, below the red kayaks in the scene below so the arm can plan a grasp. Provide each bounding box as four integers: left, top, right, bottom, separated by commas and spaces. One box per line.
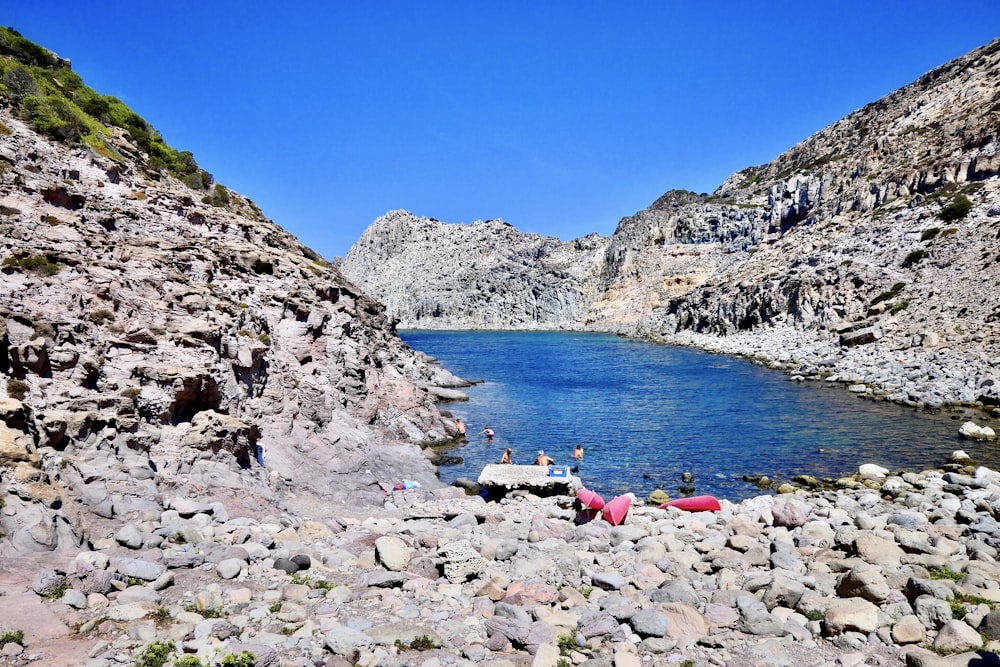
0, 460, 1000, 667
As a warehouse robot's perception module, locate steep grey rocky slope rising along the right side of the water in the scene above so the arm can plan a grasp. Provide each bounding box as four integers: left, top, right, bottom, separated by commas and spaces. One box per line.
638, 41, 1000, 404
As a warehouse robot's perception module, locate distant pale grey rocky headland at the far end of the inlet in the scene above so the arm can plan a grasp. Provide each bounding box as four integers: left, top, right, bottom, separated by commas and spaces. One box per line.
340, 211, 607, 329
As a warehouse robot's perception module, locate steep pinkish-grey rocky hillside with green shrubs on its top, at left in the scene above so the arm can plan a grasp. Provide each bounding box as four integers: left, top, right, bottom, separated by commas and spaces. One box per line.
0, 30, 455, 553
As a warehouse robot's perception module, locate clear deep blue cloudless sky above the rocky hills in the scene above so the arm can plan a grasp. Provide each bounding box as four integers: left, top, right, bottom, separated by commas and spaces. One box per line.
7, 0, 1000, 259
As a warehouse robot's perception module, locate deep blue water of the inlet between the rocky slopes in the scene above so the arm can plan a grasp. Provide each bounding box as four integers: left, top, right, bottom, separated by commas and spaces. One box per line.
400, 331, 1000, 500
